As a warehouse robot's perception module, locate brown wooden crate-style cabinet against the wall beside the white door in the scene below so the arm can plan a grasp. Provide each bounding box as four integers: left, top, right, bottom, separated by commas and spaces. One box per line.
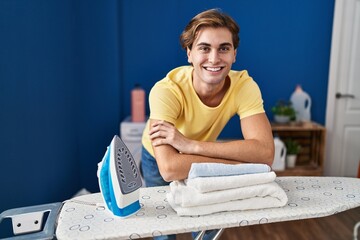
271, 122, 326, 176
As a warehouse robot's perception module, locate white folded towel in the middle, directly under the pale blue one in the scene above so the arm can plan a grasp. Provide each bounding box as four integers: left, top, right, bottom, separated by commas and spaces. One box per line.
184, 171, 276, 193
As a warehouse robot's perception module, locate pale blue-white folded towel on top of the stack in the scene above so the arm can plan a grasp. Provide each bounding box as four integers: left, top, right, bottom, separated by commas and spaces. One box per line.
188, 163, 271, 179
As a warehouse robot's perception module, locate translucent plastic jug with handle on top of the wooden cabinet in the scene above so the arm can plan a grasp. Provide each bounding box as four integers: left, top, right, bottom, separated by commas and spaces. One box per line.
290, 85, 311, 122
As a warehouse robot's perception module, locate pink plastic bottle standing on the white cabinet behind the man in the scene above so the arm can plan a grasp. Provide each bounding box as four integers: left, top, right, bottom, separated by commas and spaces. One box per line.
131, 84, 145, 122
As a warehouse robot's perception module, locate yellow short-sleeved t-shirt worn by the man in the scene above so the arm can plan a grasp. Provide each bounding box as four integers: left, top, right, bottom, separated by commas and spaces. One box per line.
142, 66, 264, 156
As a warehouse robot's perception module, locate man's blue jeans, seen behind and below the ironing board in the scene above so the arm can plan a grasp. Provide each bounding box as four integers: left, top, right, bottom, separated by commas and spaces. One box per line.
140, 147, 217, 240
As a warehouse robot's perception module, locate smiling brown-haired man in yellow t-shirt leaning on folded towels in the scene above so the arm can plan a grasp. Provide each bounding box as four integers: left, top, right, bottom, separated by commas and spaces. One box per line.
141, 9, 274, 187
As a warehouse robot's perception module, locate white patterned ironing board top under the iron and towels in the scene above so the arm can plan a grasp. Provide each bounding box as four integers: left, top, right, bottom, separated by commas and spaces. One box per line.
56, 177, 360, 240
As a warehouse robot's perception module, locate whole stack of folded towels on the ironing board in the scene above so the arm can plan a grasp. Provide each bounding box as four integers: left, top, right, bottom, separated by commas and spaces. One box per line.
167, 163, 288, 216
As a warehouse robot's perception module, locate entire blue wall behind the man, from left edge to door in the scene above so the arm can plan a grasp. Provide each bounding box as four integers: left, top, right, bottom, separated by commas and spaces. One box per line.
0, 0, 334, 212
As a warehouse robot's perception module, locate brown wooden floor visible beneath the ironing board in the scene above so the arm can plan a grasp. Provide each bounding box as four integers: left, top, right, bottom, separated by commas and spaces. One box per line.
171, 207, 360, 240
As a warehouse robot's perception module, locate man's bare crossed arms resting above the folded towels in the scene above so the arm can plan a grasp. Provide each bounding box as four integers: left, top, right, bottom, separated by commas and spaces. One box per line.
149, 113, 274, 181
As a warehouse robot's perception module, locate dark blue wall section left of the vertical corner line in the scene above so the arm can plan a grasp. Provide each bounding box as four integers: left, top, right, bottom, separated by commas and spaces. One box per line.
0, 0, 122, 214
